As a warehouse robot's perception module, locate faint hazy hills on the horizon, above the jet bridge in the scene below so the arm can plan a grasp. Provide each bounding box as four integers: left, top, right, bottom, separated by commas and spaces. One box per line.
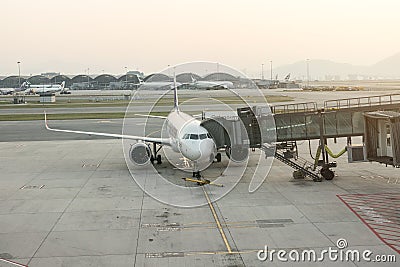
265, 53, 400, 80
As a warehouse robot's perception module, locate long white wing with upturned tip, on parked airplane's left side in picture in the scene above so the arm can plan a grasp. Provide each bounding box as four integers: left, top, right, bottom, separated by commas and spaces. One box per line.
44, 112, 171, 146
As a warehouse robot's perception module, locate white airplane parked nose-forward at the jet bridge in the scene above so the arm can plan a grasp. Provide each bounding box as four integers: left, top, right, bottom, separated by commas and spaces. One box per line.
44, 78, 225, 179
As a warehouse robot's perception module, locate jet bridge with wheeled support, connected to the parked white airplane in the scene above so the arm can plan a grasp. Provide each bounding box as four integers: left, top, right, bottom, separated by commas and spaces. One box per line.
202, 94, 400, 181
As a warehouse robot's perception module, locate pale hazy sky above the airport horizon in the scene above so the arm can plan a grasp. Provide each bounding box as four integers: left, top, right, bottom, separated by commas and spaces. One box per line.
0, 0, 400, 76
